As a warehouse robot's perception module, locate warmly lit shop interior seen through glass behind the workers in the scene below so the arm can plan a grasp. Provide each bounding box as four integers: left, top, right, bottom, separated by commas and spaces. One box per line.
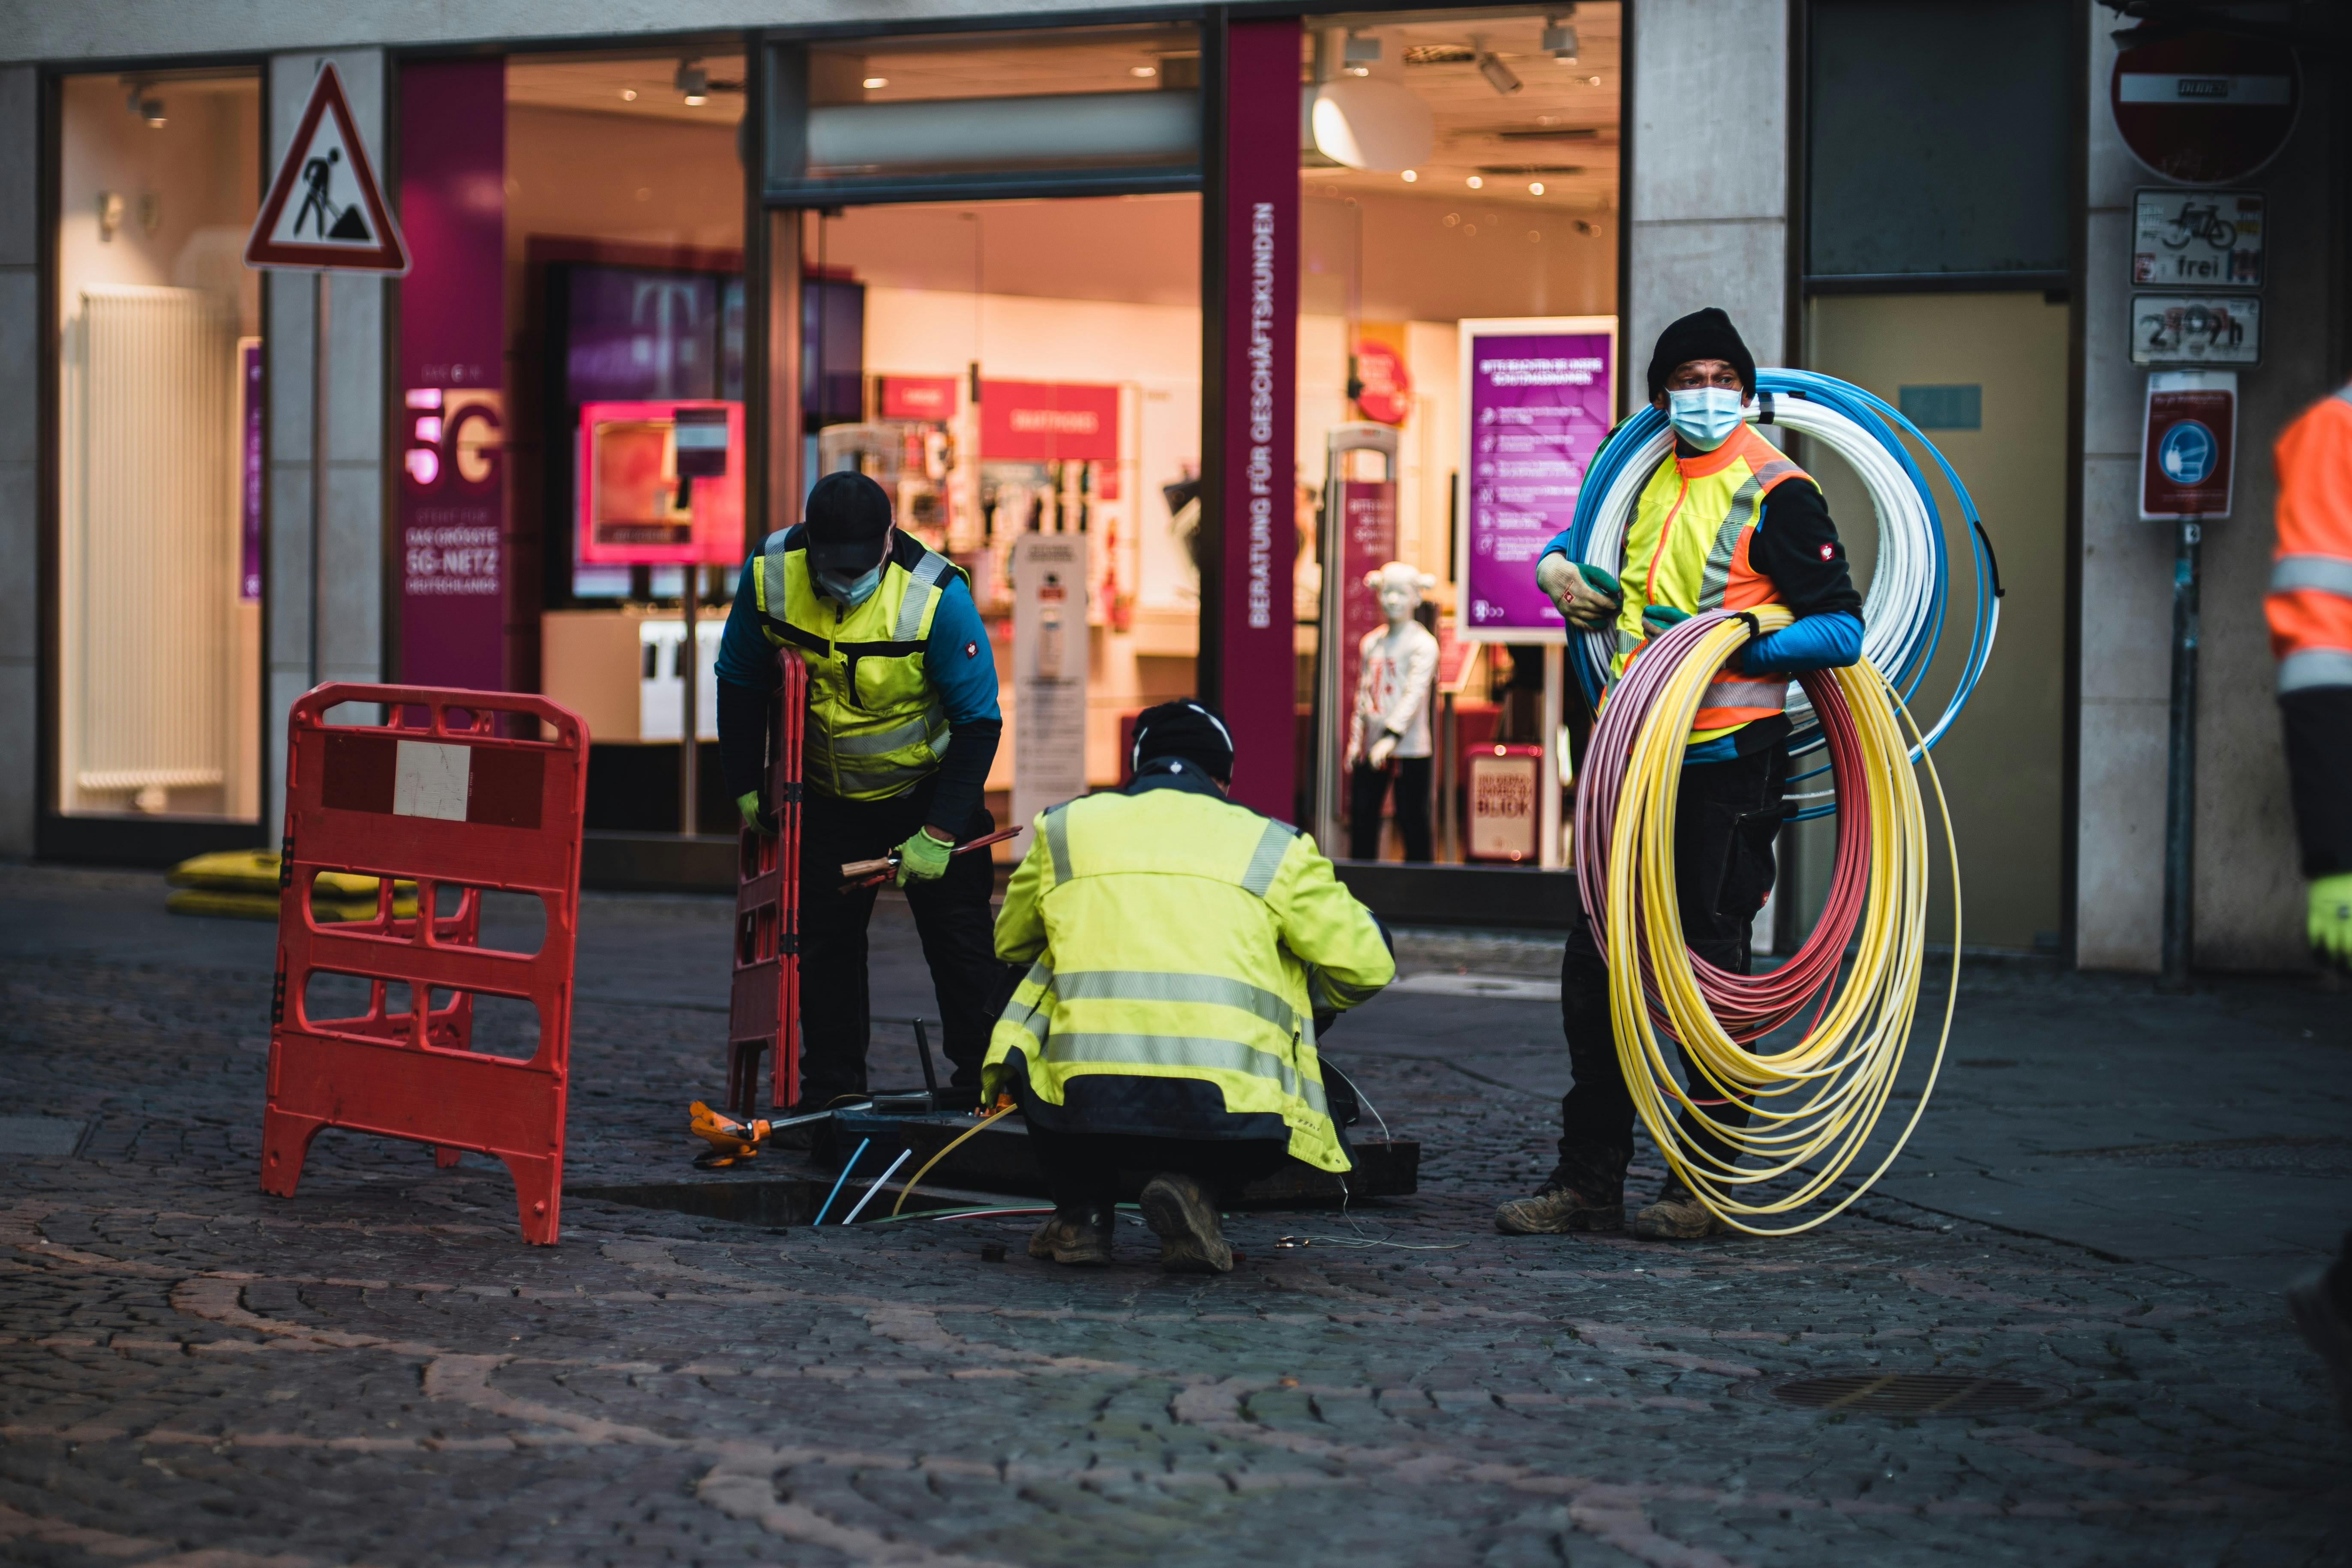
506, 5, 1618, 858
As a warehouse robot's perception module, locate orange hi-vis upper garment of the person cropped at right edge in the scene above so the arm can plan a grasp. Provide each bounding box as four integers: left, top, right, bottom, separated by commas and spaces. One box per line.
2262, 386, 2352, 696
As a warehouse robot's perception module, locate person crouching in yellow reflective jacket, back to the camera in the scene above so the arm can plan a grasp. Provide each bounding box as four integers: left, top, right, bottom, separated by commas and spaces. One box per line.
983, 703, 1397, 1274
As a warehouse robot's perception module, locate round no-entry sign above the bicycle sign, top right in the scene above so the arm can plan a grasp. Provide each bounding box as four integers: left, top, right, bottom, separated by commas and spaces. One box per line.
2107, 30, 2303, 186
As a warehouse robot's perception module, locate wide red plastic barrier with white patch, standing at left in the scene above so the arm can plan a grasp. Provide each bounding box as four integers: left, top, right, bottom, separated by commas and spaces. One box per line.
261, 684, 588, 1246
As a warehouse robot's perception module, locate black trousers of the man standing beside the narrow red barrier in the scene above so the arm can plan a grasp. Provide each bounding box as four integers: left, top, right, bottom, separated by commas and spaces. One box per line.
800, 780, 1014, 1109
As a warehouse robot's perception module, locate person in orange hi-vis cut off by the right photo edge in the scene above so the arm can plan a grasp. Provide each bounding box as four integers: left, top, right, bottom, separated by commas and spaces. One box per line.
2265, 383, 2352, 1420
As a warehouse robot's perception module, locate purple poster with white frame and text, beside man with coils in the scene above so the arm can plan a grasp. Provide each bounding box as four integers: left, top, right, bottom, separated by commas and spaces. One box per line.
1456, 315, 1616, 642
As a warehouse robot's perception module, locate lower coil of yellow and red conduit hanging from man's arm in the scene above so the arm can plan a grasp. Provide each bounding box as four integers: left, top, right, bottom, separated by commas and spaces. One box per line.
1576, 606, 1962, 1237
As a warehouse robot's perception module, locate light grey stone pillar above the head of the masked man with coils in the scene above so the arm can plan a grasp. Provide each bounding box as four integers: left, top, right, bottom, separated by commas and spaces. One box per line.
1623, 0, 1792, 374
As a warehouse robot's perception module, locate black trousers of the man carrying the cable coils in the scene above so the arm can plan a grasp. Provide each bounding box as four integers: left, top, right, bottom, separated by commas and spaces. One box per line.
1552, 745, 1788, 1204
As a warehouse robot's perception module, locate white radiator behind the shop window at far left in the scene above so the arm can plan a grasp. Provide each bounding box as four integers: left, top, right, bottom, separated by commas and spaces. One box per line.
59, 287, 237, 811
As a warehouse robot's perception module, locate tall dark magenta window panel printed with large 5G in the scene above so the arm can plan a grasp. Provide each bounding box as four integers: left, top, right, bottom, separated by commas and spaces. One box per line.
397, 59, 508, 691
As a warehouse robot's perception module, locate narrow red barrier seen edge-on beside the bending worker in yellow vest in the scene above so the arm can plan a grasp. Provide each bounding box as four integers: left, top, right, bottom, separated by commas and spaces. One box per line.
727, 649, 809, 1117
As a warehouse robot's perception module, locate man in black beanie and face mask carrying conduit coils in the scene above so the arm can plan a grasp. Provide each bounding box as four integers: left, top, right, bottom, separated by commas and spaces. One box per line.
1494, 308, 1863, 1239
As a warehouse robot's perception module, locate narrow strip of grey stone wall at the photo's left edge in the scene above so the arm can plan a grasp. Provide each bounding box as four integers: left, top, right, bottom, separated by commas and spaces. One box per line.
0, 66, 40, 856
